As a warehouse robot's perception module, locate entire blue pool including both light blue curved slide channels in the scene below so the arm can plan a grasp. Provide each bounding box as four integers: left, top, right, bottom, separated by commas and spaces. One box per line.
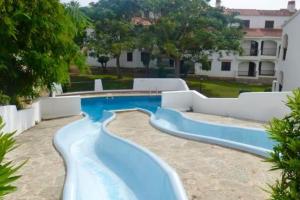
54, 96, 273, 200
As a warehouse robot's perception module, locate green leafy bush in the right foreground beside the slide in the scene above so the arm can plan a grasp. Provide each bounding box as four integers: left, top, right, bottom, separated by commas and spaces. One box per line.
267, 90, 300, 200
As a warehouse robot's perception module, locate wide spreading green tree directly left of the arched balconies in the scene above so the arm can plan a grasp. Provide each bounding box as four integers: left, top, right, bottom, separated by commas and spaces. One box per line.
151, 0, 243, 77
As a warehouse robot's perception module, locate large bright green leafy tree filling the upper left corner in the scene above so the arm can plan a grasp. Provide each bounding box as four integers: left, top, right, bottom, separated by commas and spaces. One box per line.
0, 0, 85, 103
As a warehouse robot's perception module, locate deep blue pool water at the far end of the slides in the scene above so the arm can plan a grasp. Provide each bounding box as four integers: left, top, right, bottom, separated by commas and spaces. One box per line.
81, 96, 161, 121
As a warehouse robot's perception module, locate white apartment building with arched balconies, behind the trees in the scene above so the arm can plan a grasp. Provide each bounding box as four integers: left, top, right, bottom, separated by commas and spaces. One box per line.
195, 0, 296, 83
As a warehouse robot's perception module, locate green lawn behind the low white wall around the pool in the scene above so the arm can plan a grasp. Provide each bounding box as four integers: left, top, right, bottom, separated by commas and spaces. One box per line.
65, 74, 271, 97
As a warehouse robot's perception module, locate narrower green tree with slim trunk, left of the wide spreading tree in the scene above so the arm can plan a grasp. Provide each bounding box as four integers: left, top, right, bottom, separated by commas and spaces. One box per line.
87, 0, 139, 78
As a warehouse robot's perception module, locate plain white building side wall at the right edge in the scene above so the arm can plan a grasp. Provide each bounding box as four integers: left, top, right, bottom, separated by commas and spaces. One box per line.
273, 11, 300, 91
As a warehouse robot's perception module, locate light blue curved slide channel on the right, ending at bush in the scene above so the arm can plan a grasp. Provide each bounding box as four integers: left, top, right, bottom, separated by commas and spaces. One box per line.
150, 108, 275, 157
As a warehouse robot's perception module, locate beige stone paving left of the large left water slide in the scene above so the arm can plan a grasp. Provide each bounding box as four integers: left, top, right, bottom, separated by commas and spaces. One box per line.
5, 116, 80, 200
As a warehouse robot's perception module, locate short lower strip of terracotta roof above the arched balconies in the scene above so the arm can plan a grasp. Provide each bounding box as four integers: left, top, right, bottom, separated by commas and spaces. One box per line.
244, 28, 282, 38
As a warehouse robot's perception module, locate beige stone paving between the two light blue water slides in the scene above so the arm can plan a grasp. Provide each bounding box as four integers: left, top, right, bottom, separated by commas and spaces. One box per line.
109, 111, 278, 200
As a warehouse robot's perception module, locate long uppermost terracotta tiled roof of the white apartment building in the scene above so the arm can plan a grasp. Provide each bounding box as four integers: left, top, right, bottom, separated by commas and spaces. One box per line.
225, 9, 295, 17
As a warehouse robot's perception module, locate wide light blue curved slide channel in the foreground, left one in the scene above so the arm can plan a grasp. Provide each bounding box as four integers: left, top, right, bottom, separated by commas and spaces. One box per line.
54, 112, 187, 200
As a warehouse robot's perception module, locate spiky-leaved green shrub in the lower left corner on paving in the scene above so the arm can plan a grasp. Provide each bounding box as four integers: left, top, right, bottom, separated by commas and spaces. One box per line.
0, 117, 25, 199
